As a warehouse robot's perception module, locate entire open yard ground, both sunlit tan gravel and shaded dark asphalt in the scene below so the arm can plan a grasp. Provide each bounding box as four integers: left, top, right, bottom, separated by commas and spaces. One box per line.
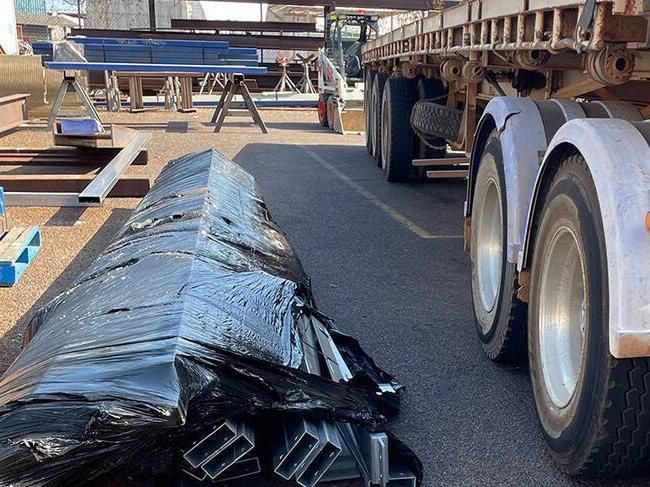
0, 110, 649, 487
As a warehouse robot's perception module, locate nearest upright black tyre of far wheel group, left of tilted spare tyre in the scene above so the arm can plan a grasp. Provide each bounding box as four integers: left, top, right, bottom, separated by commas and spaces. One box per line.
381, 78, 415, 182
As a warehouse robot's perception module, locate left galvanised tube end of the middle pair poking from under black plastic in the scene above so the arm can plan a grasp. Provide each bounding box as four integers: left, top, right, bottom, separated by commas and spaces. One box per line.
273, 418, 320, 480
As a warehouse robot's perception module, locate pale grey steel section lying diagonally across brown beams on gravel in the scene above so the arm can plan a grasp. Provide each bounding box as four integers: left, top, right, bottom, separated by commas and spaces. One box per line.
79, 133, 151, 203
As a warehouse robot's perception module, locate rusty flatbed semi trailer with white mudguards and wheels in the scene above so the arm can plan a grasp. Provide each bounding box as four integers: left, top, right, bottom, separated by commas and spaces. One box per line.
362, 0, 650, 477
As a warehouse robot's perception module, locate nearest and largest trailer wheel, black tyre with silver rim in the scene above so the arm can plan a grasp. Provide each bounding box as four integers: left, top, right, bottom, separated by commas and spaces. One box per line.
528, 153, 650, 476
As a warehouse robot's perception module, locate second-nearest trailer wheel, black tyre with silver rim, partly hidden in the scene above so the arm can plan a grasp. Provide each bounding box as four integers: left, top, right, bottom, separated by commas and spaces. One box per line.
470, 131, 526, 363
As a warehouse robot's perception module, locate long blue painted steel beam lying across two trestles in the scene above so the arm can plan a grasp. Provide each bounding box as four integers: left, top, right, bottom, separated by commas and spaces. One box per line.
45, 62, 266, 74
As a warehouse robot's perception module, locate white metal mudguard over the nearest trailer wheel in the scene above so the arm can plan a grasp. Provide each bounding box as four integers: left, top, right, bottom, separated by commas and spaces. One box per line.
518, 119, 650, 358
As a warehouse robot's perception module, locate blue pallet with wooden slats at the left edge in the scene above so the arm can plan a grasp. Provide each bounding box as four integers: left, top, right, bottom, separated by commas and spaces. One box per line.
0, 227, 41, 287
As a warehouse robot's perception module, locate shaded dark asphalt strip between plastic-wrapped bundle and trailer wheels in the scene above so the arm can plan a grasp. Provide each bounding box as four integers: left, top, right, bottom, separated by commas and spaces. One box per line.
234, 137, 648, 486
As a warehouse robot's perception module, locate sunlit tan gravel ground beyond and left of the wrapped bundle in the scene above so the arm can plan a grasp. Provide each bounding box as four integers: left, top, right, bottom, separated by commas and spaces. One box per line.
0, 109, 324, 371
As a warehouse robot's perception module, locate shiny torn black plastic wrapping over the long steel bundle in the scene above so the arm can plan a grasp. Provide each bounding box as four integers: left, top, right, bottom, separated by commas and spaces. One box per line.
0, 151, 419, 487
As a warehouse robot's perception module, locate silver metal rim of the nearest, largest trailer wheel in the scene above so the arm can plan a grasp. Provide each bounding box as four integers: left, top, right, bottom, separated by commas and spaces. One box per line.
538, 226, 588, 408
